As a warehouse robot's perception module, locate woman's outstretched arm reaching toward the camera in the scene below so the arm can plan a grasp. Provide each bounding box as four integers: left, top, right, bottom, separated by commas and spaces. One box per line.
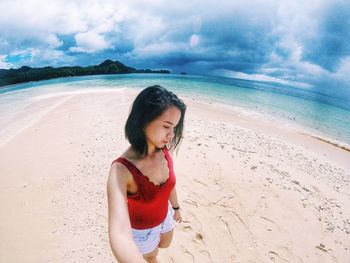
107, 163, 145, 263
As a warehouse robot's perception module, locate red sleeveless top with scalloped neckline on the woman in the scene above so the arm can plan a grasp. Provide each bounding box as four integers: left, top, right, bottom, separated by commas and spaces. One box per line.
112, 147, 176, 229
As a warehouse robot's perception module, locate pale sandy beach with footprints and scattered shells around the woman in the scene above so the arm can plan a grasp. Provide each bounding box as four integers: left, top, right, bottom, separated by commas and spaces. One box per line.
0, 89, 350, 263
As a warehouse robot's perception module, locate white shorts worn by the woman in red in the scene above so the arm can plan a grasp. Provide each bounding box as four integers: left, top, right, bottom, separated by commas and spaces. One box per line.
131, 205, 175, 254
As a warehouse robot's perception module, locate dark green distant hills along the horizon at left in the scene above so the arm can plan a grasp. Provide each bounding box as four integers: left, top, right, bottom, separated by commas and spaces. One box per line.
0, 59, 170, 87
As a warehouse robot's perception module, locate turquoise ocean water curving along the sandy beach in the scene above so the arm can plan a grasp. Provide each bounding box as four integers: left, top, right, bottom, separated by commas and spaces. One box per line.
0, 74, 350, 145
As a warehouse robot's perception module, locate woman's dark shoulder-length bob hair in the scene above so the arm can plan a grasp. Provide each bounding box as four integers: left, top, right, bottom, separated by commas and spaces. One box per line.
125, 85, 186, 155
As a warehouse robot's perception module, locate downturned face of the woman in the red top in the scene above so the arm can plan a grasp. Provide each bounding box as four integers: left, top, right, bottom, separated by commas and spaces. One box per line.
145, 106, 181, 149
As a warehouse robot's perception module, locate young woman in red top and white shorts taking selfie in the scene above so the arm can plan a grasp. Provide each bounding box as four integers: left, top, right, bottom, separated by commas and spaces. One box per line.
107, 85, 186, 263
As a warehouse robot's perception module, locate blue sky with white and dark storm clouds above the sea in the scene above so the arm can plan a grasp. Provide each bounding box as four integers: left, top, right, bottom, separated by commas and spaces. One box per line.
0, 0, 350, 97
